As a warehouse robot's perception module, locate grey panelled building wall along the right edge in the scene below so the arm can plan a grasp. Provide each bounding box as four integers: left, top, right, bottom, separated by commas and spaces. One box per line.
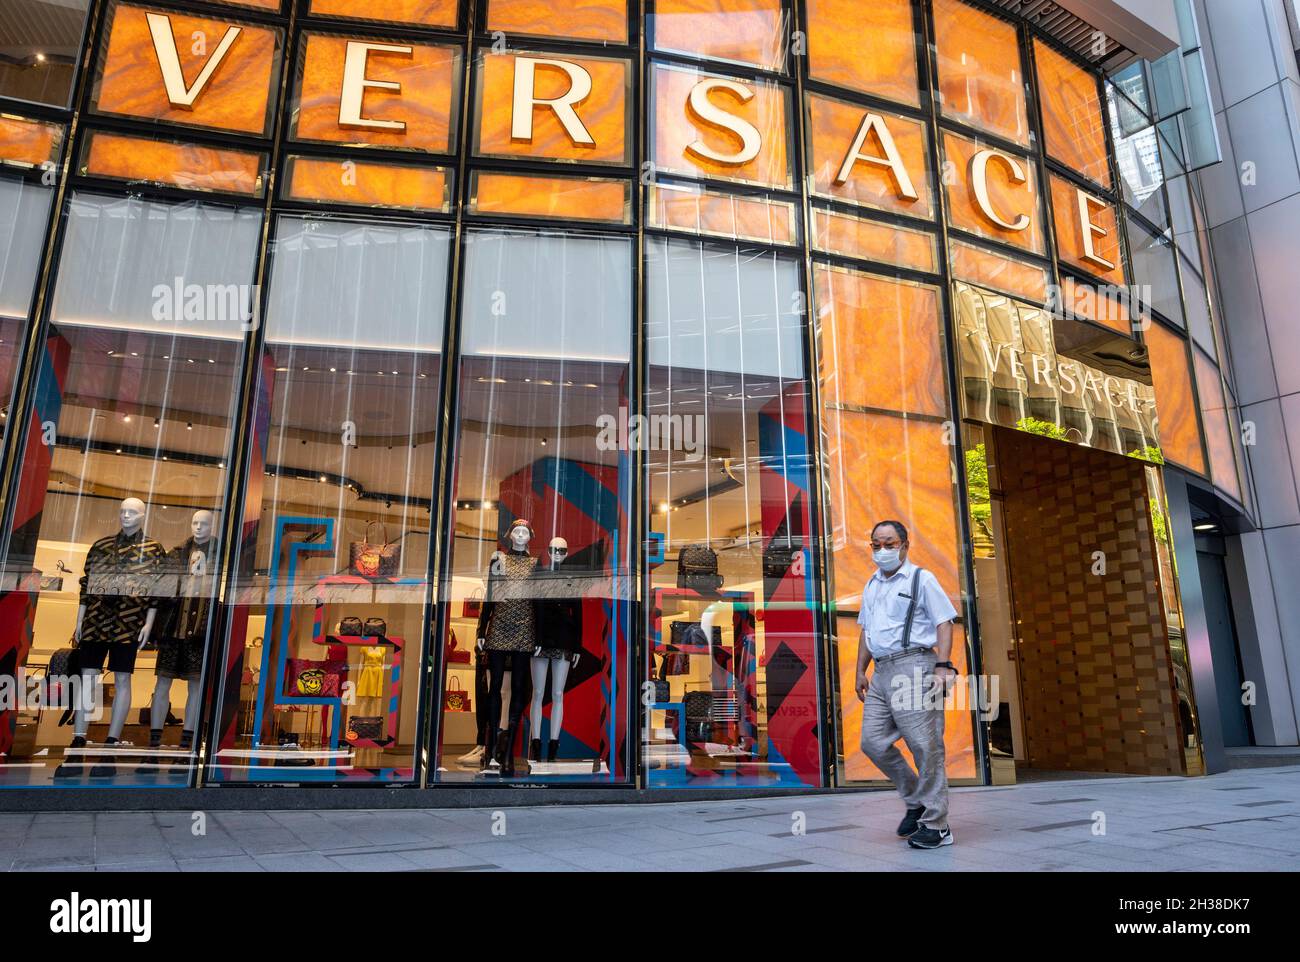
1195, 0, 1300, 745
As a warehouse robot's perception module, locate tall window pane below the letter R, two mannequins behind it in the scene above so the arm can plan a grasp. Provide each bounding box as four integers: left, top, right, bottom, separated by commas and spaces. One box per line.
437, 230, 634, 784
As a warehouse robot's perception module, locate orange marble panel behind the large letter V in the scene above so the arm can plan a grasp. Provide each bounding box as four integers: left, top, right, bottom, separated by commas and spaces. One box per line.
95, 4, 281, 135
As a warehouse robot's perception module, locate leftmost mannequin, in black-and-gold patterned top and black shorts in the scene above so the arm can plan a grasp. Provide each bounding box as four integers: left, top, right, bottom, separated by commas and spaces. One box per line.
56, 498, 166, 777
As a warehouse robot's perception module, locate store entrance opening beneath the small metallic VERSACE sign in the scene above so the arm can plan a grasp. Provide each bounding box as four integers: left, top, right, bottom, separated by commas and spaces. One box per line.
967, 426, 1191, 781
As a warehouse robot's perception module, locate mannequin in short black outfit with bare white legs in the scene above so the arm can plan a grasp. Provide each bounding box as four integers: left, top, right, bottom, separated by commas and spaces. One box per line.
528, 538, 582, 762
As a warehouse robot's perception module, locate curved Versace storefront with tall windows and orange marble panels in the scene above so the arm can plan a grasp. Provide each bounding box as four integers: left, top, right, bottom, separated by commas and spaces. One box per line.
0, 0, 1248, 788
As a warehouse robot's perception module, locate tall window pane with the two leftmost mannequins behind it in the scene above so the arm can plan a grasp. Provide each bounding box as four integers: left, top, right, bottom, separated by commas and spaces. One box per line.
0, 194, 261, 787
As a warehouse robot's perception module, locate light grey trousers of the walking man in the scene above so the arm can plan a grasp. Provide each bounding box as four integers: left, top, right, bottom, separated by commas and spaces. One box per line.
862, 649, 948, 831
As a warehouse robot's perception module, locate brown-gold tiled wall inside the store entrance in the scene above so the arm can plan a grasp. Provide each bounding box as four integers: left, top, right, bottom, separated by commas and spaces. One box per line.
997, 430, 1184, 775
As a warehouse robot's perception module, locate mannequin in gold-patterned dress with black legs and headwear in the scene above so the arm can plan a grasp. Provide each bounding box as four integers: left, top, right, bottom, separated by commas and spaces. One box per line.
476, 519, 537, 777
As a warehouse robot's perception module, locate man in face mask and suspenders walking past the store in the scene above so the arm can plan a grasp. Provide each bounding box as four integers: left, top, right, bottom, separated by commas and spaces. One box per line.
857, 521, 957, 849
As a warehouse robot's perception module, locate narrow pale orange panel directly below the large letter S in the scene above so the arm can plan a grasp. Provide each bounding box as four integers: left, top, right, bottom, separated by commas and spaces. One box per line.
646, 183, 800, 246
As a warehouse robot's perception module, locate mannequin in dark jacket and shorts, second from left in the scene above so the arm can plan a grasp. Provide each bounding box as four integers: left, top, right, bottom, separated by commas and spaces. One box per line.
150, 511, 217, 769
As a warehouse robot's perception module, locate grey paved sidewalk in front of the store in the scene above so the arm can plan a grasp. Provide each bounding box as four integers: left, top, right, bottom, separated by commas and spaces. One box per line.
0, 766, 1300, 872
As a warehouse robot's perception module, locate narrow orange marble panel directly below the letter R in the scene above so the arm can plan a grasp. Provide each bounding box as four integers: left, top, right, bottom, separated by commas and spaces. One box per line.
469, 170, 632, 224
